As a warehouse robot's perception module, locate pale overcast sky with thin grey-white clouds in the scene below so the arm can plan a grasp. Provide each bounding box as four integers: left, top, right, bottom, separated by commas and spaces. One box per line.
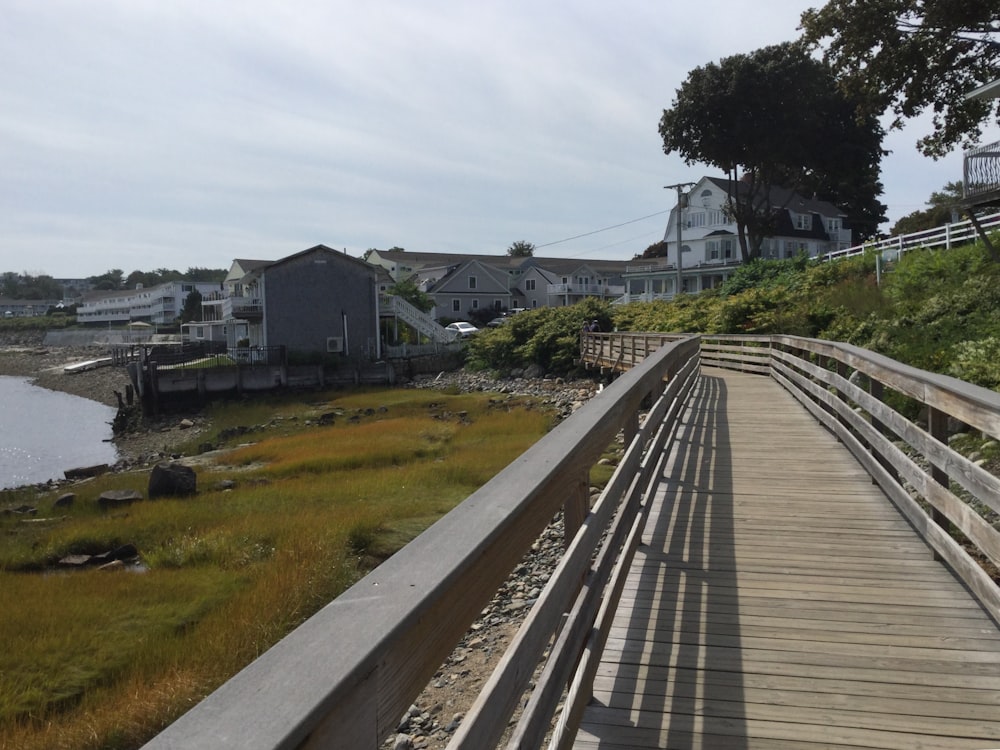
0, 0, 997, 277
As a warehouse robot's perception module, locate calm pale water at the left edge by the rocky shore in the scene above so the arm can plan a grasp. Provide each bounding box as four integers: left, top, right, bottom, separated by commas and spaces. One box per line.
0, 375, 118, 488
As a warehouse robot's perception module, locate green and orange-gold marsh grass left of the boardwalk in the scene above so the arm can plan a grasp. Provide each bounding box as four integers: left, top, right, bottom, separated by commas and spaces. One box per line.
0, 390, 551, 750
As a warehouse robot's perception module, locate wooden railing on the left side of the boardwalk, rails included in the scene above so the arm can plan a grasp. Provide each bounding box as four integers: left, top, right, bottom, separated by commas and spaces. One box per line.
145, 337, 699, 750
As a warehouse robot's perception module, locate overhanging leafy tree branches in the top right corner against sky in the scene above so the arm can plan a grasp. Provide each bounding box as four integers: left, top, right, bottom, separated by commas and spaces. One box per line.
802, 0, 1000, 158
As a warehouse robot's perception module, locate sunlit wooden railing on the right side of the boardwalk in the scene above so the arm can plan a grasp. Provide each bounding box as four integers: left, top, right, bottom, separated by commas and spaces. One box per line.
728, 336, 1000, 623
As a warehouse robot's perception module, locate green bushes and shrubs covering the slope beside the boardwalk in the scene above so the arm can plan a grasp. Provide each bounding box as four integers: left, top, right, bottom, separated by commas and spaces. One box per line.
469, 243, 1000, 389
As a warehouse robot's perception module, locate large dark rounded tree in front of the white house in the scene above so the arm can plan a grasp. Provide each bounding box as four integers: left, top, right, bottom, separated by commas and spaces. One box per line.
660, 43, 885, 261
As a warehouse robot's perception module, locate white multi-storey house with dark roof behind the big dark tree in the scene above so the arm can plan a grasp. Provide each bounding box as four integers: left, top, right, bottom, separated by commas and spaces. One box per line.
624, 177, 852, 301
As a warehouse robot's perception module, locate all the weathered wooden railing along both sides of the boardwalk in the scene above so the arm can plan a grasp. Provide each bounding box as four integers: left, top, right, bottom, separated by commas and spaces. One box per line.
141, 333, 1000, 750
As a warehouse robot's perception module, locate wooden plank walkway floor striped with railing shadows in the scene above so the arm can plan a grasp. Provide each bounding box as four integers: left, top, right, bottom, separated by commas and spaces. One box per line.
575, 369, 1000, 750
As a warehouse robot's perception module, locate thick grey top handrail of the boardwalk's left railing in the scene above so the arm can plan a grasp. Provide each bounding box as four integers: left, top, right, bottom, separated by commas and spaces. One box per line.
146, 338, 698, 750
